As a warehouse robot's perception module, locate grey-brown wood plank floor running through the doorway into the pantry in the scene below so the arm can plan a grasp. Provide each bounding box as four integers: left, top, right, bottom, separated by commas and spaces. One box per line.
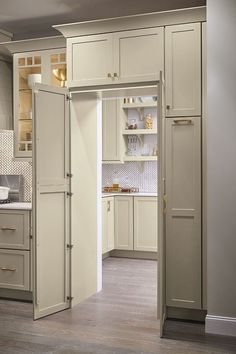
0, 258, 236, 354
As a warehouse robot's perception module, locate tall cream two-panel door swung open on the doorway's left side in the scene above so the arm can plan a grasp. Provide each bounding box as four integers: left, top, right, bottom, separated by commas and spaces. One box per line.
33, 84, 71, 319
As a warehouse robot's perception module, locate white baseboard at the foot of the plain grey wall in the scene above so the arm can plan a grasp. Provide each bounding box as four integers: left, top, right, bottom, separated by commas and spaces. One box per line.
205, 315, 236, 337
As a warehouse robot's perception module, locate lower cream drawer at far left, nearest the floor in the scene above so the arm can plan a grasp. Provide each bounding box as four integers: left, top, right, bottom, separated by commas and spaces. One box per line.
0, 250, 30, 290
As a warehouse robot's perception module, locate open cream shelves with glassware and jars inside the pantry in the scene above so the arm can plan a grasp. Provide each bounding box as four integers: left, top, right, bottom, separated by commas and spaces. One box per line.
121, 97, 158, 162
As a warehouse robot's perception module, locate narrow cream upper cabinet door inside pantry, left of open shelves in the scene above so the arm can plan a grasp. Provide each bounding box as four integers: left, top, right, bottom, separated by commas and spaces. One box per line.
102, 99, 122, 163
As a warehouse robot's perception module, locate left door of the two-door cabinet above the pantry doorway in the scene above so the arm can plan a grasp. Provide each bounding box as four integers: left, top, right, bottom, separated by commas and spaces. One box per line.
67, 34, 113, 87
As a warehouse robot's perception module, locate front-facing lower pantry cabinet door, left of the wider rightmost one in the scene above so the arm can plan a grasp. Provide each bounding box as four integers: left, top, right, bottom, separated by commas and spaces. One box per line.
115, 196, 134, 250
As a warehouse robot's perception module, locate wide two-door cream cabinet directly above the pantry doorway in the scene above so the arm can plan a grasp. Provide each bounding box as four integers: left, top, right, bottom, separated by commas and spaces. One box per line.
67, 27, 164, 87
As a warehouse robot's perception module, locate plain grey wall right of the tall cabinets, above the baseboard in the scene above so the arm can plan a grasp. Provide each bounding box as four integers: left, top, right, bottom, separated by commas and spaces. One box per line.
207, 0, 236, 318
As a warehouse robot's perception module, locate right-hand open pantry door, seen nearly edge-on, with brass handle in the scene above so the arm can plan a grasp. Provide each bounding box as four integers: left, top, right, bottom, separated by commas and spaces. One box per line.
157, 72, 166, 337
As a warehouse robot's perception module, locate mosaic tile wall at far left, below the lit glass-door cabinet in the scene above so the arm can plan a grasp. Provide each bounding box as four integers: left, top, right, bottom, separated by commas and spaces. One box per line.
0, 130, 32, 202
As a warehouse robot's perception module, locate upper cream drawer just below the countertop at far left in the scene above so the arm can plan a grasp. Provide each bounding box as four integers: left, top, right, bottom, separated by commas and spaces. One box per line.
0, 211, 29, 249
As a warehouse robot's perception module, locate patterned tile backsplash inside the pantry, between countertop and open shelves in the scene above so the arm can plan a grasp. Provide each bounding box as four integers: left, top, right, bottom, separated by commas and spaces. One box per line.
102, 161, 157, 193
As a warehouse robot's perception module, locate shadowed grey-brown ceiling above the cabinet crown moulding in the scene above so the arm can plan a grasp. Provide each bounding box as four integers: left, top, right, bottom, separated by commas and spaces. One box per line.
0, 0, 206, 39
